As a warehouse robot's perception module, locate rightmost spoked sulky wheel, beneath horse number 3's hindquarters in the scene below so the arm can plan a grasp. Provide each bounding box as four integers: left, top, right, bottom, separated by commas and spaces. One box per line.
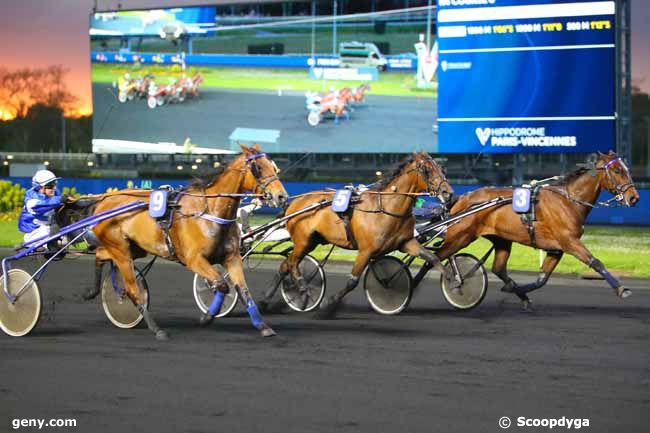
440, 253, 488, 310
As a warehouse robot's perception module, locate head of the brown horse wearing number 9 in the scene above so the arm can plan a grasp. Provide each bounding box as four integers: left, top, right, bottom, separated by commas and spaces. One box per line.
239, 144, 289, 207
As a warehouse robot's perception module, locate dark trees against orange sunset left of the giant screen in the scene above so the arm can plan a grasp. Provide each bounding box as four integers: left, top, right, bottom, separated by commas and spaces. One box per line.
0, 65, 92, 152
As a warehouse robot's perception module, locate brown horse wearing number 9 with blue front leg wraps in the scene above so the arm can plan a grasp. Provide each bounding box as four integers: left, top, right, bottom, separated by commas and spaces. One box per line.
71, 145, 288, 339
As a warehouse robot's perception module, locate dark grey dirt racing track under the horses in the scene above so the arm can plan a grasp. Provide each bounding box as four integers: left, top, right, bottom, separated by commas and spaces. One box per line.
0, 260, 650, 433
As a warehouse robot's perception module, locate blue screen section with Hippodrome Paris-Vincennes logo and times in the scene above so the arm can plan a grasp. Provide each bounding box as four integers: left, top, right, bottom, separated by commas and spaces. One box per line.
437, 0, 616, 153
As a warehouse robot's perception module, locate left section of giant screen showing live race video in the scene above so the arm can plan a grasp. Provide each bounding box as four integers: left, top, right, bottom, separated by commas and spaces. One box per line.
90, 2, 438, 153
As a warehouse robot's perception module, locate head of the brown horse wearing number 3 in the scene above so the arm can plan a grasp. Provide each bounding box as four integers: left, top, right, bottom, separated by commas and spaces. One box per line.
590, 150, 639, 207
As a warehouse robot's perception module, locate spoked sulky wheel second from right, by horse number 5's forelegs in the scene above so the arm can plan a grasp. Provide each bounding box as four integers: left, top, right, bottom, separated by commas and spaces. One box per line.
363, 256, 413, 314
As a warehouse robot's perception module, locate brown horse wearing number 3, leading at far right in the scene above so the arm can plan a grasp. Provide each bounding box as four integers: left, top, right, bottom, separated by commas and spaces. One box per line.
425, 152, 639, 307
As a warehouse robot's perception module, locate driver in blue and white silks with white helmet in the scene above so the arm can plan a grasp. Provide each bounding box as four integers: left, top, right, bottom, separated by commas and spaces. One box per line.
18, 170, 65, 242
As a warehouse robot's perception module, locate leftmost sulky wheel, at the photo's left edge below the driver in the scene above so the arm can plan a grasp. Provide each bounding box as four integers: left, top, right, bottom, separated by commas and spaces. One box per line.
0, 269, 42, 337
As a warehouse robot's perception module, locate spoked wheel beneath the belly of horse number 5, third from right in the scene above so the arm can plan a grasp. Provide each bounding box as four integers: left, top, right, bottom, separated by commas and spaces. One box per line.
281, 255, 326, 313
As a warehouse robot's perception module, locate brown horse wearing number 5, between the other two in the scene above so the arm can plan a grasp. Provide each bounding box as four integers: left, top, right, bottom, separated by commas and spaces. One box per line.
261, 153, 453, 318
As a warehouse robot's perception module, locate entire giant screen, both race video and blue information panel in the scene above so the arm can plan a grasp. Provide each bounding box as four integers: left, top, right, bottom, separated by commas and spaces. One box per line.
90, 0, 616, 154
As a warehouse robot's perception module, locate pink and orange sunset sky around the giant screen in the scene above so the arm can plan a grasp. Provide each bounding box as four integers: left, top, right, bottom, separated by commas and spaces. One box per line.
0, 0, 650, 114
